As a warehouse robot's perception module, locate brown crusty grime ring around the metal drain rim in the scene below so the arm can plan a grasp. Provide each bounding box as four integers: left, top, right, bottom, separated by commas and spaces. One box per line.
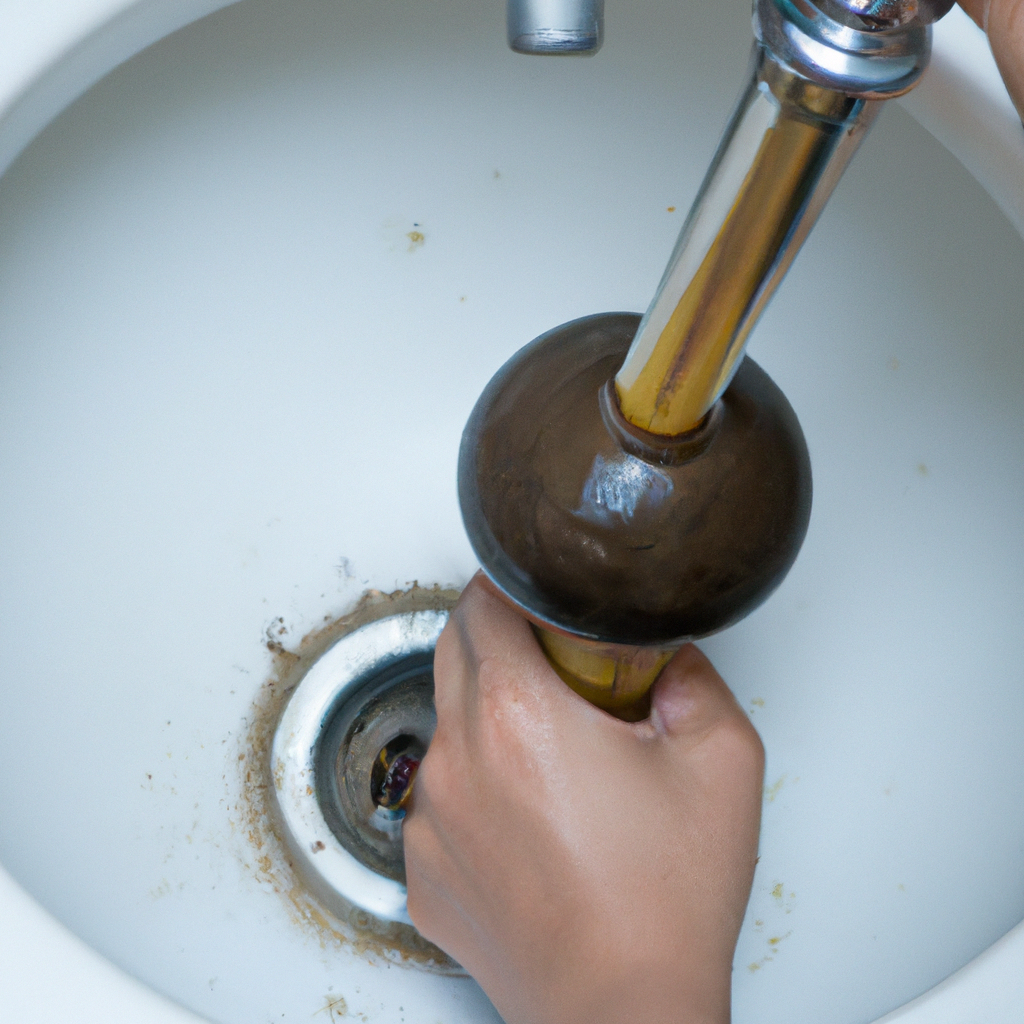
232, 584, 464, 970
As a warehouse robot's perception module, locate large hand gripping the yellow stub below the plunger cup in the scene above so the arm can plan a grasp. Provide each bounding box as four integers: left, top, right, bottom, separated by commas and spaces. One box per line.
403, 575, 764, 1024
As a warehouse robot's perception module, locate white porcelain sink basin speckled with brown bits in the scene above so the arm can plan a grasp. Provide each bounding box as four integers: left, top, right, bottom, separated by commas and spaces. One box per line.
0, 0, 1024, 1024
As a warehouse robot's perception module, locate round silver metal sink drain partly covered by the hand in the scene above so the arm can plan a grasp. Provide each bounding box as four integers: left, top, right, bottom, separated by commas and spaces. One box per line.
270, 610, 449, 925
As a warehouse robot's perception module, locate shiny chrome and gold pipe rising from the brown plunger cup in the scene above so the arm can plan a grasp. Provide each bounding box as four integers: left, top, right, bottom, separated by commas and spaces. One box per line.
615, 0, 949, 435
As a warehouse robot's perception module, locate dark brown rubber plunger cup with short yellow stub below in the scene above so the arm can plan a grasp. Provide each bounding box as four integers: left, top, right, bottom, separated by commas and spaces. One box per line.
459, 313, 811, 718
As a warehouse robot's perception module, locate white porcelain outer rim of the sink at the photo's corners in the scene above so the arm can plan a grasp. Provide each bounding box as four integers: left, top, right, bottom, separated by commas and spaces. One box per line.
0, 0, 1024, 1024
